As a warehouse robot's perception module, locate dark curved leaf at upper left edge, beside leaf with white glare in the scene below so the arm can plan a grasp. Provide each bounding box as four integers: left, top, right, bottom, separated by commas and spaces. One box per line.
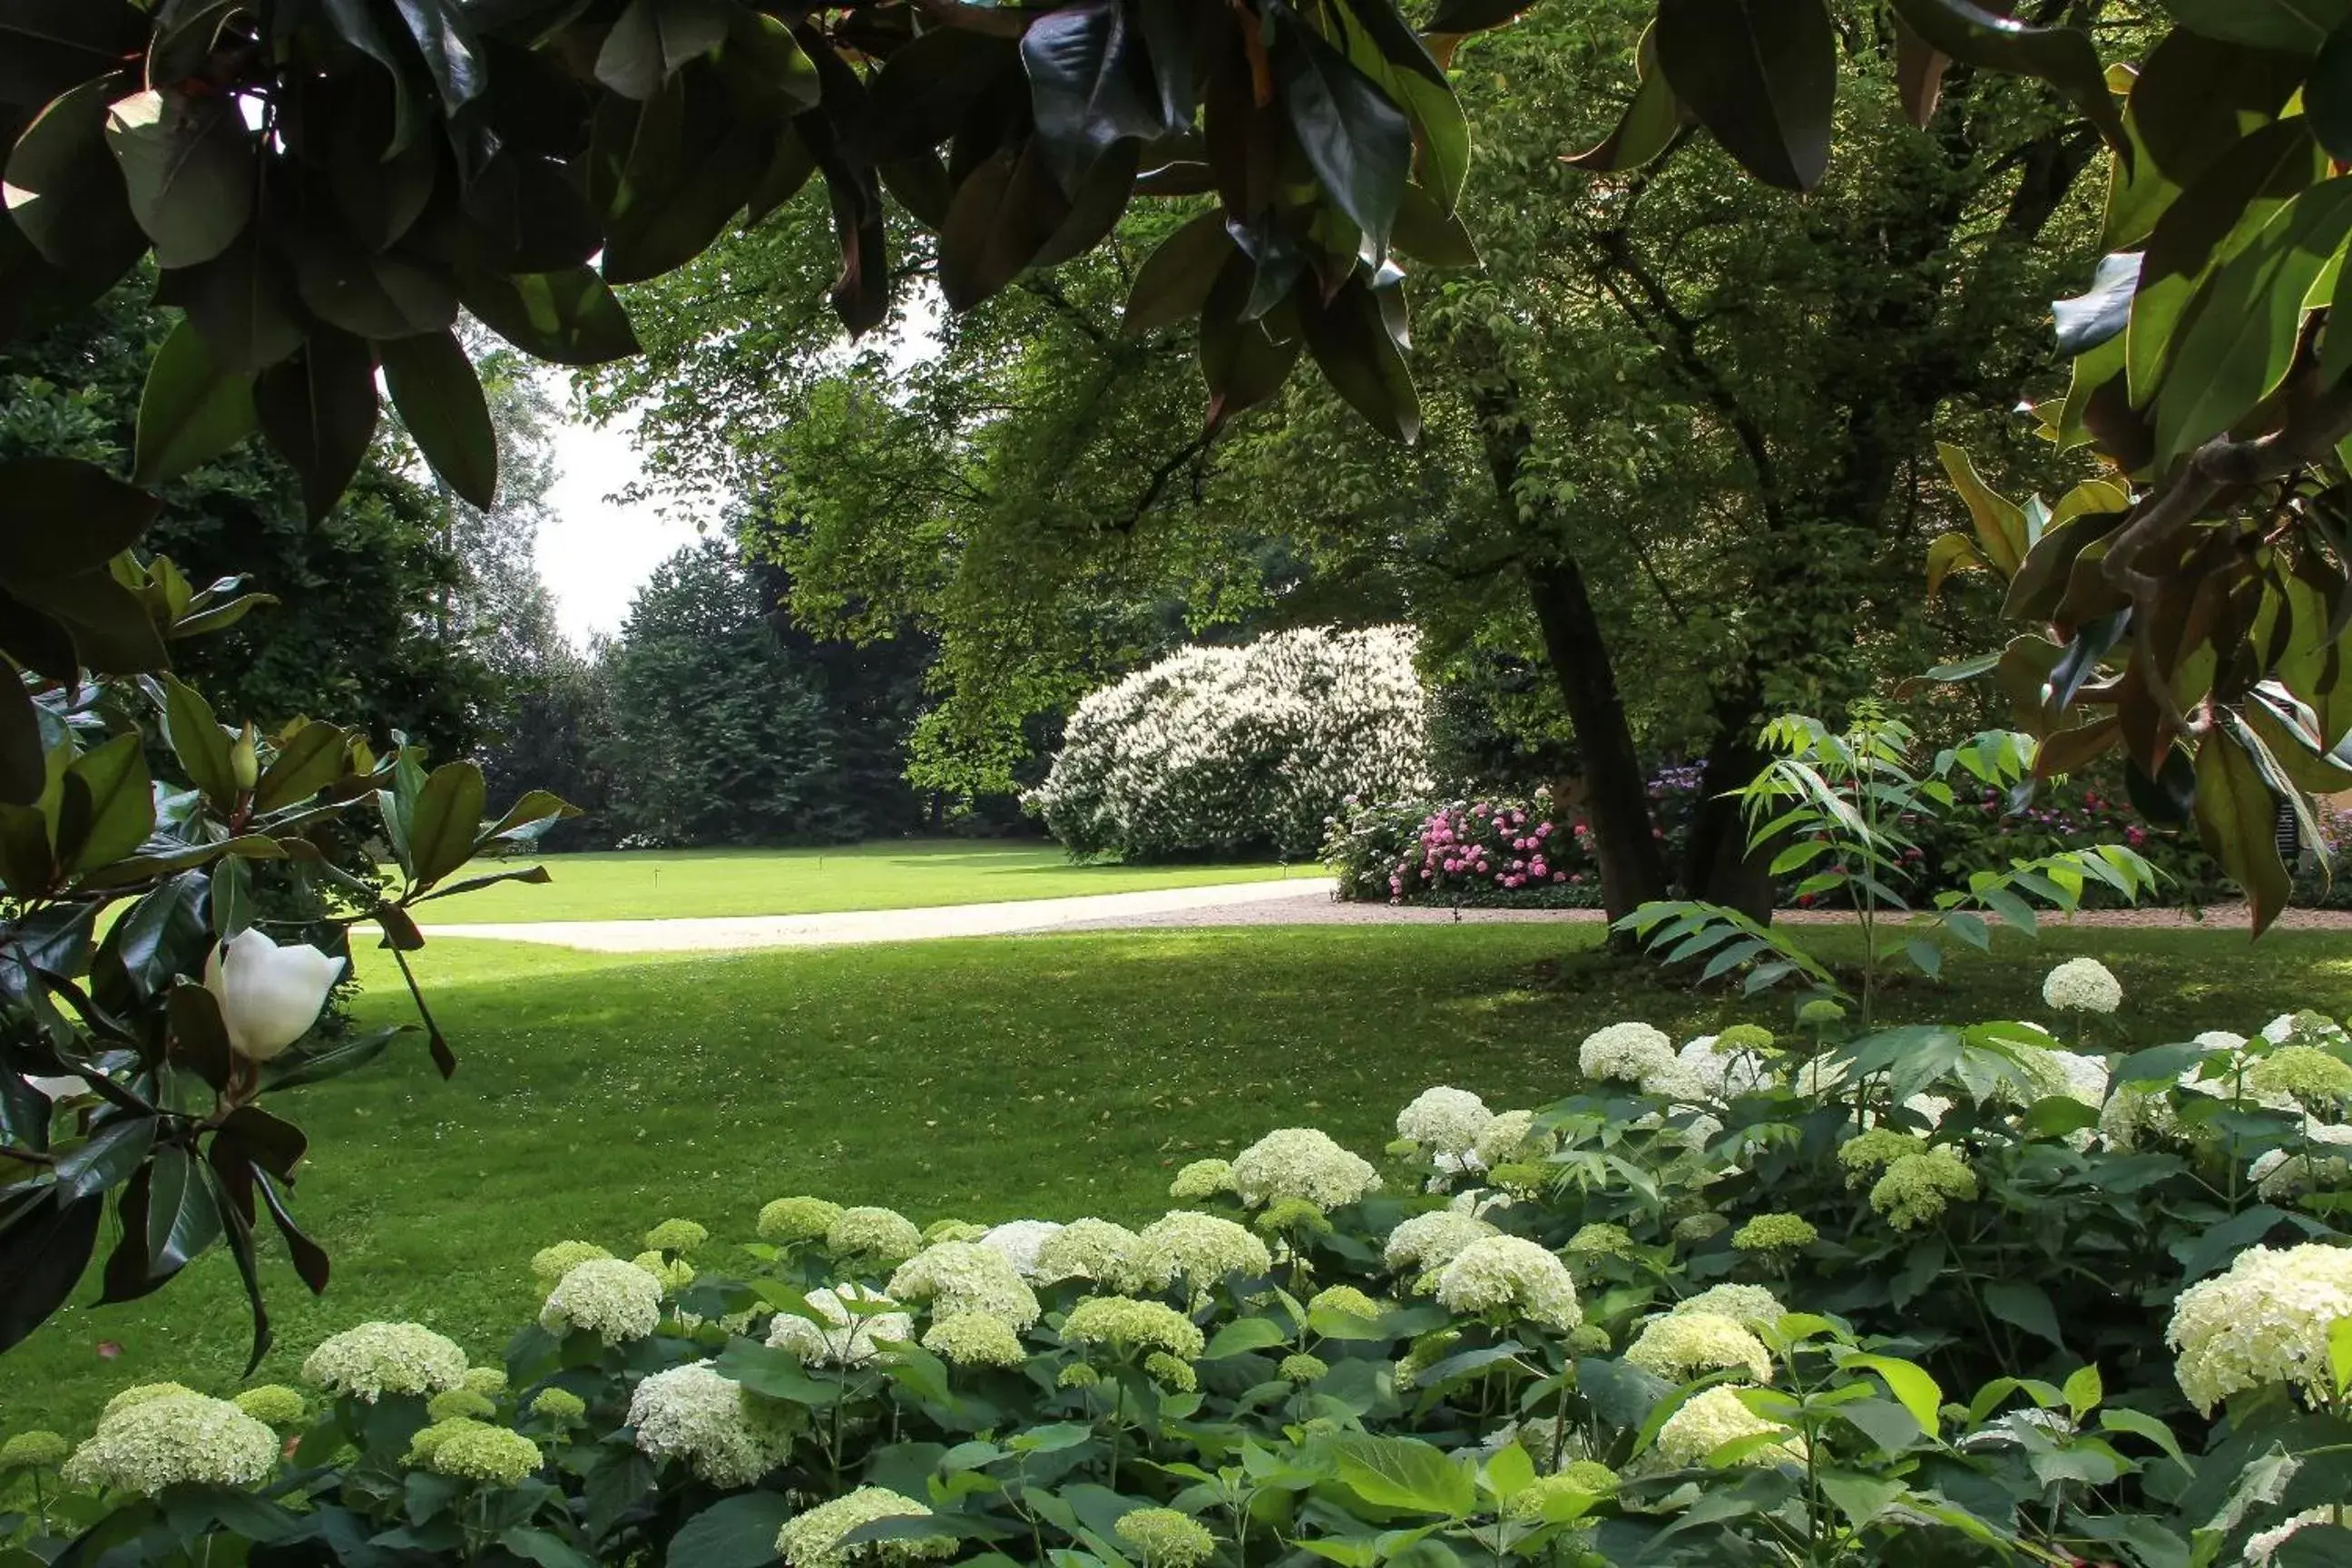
7, 75, 148, 276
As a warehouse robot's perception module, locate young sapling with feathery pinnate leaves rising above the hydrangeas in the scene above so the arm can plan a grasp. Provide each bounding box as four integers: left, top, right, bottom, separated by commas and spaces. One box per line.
1618, 705, 2157, 1025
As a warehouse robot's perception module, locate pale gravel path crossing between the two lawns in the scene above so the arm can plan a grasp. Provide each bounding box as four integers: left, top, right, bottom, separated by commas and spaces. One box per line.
426, 877, 2352, 952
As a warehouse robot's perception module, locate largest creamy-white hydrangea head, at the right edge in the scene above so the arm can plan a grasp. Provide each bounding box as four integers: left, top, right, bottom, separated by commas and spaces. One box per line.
2164, 1241, 2352, 1416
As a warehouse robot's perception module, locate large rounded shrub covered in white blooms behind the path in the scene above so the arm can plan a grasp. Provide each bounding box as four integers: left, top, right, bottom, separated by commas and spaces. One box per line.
1028, 625, 1430, 860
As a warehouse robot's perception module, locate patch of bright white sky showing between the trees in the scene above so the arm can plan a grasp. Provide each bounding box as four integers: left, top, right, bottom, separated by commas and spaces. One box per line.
539, 383, 696, 644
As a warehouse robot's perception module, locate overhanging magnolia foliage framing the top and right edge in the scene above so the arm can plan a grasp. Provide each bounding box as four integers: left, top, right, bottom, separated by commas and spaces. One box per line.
0, 0, 2352, 922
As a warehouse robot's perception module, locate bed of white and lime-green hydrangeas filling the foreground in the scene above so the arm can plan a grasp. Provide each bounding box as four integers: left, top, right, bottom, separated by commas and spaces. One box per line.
0, 966, 2352, 1568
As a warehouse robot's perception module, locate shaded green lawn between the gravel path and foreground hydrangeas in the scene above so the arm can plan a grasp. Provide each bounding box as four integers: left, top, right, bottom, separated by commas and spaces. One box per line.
0, 926, 2352, 1432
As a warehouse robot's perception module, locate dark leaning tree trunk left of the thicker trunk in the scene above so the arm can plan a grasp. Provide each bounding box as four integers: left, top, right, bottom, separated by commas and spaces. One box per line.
1524, 560, 1668, 919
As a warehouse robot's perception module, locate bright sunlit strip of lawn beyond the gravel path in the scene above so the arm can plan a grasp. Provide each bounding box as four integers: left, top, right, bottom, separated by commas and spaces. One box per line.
418, 839, 1322, 924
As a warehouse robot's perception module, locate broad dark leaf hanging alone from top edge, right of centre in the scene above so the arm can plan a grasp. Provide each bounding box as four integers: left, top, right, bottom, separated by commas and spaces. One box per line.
1658, 0, 1834, 191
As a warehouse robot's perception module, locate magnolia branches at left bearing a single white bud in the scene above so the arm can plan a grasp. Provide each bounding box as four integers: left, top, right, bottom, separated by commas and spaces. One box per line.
0, 550, 572, 1361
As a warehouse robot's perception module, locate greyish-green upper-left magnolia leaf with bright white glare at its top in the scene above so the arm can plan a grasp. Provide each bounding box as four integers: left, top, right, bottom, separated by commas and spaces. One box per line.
106, 89, 259, 268
